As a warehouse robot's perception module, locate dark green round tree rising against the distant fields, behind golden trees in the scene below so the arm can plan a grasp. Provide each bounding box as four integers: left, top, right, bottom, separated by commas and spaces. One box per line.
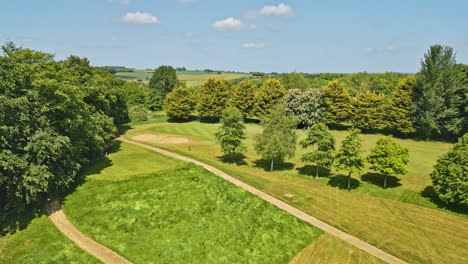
149, 66, 180, 98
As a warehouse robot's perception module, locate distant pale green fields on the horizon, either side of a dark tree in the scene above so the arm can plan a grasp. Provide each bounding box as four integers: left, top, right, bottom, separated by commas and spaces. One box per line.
114, 70, 252, 87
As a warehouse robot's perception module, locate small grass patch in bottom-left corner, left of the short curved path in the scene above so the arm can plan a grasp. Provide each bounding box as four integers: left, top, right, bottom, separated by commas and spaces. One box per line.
0, 213, 97, 264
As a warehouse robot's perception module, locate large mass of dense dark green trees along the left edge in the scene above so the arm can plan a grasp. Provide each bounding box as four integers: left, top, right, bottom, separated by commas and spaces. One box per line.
0, 43, 128, 211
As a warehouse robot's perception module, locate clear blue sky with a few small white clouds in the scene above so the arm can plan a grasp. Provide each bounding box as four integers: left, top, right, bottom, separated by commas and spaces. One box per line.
0, 0, 468, 73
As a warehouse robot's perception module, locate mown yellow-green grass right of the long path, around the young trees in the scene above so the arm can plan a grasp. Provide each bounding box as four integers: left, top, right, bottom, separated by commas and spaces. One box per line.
127, 116, 468, 263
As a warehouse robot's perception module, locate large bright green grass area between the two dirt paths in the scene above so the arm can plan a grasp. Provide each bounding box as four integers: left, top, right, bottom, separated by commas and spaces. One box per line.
63, 143, 378, 263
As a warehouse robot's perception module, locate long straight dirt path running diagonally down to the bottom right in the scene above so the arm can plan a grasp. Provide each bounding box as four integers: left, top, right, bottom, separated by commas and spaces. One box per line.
117, 137, 407, 264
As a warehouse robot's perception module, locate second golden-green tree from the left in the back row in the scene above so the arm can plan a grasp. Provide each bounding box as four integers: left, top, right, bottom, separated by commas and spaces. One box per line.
197, 78, 231, 119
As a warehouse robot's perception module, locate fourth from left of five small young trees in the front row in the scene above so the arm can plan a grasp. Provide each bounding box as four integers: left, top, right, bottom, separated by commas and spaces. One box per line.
336, 129, 365, 190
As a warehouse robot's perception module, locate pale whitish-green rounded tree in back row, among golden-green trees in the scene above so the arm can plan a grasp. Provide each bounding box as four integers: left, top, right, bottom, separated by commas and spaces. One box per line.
284, 89, 325, 127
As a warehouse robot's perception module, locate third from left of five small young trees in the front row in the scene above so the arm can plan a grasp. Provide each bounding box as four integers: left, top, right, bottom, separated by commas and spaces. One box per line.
300, 123, 335, 178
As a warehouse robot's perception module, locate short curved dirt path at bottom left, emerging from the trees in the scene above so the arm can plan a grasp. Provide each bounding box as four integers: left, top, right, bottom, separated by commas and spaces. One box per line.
46, 198, 132, 264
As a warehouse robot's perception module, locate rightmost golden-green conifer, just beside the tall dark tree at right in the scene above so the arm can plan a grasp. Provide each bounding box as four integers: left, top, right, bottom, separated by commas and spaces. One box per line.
383, 76, 415, 135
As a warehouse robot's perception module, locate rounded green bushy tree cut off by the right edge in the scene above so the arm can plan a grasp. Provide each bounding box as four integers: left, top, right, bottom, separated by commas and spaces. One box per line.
431, 133, 468, 207
